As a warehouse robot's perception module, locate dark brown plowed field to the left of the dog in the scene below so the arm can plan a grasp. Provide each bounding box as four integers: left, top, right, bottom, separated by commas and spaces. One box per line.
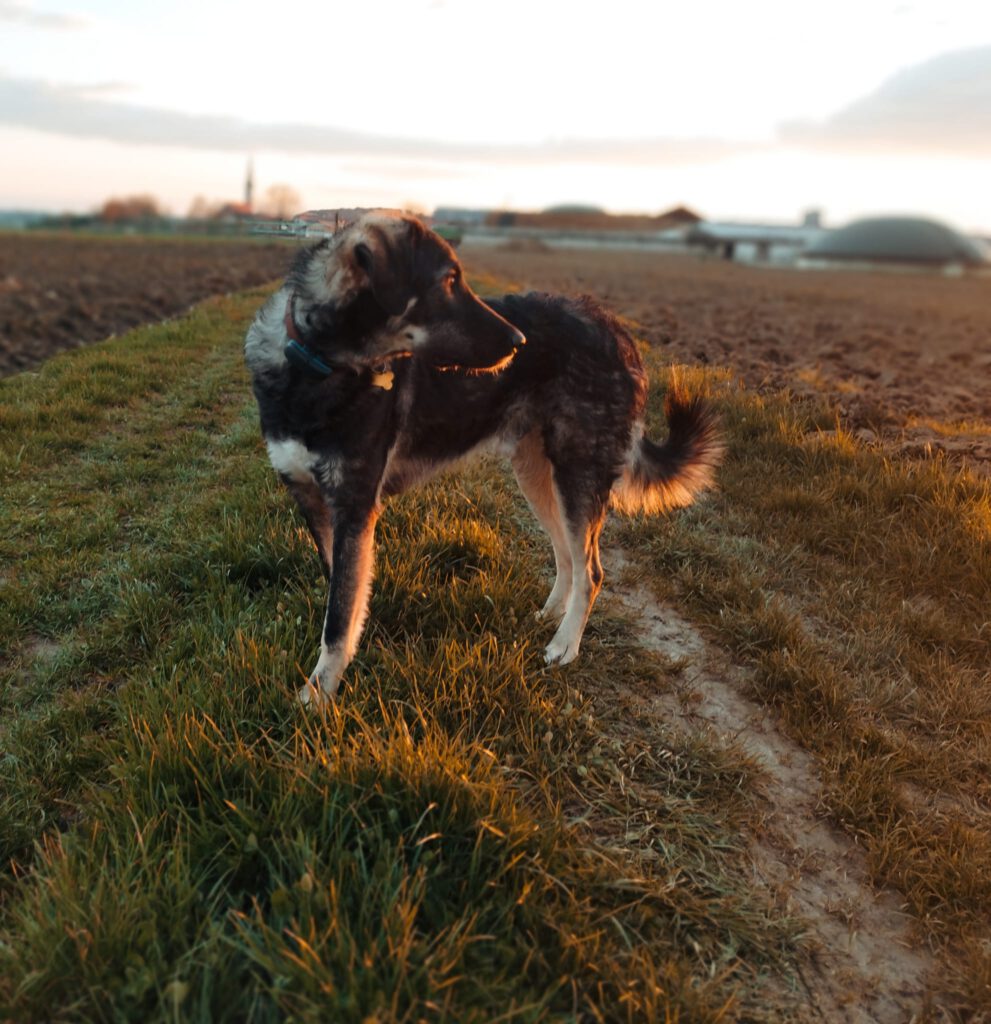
0, 233, 292, 377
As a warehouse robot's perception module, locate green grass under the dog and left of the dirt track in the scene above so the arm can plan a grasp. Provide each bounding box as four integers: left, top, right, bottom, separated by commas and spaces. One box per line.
0, 292, 804, 1021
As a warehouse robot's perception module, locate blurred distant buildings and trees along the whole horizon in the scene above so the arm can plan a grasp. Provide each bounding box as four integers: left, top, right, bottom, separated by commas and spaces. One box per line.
0, 163, 991, 273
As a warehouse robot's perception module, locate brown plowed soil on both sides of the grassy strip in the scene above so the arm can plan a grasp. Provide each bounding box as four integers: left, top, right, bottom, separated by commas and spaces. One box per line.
7, 234, 991, 473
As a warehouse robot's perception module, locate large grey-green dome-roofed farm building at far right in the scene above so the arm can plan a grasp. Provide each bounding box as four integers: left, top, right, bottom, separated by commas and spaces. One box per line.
802, 217, 988, 268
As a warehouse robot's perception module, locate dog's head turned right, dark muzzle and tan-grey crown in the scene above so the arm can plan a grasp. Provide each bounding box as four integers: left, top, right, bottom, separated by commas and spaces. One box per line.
288, 213, 526, 373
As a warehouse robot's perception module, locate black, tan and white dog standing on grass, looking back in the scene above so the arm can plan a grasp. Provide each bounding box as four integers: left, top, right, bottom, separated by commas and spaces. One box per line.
245, 212, 722, 703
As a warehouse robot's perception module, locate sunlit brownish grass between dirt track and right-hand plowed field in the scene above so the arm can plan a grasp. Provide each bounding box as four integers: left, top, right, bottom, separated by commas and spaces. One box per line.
618, 360, 991, 1019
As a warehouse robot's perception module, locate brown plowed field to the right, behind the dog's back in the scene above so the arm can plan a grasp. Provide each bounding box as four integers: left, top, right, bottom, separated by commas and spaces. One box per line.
462, 246, 991, 474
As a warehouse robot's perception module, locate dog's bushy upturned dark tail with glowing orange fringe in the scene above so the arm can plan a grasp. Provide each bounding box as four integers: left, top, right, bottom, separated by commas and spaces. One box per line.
612, 385, 723, 512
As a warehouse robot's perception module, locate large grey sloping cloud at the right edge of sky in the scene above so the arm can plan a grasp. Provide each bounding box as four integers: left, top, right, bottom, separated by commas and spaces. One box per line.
781, 46, 991, 157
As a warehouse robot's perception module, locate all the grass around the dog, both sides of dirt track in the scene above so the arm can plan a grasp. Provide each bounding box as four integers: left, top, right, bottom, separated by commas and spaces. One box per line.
0, 272, 991, 1021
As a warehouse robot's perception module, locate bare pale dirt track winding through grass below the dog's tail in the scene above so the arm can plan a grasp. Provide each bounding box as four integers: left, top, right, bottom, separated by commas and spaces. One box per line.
603, 546, 938, 1024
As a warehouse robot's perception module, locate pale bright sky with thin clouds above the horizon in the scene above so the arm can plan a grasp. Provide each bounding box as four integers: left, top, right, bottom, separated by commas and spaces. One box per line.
0, 0, 991, 231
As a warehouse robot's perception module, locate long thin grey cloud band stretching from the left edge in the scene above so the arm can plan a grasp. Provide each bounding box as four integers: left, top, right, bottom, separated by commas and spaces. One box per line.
0, 75, 762, 166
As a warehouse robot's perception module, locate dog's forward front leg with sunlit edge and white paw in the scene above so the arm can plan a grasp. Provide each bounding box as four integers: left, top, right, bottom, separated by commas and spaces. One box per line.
299, 508, 377, 705
